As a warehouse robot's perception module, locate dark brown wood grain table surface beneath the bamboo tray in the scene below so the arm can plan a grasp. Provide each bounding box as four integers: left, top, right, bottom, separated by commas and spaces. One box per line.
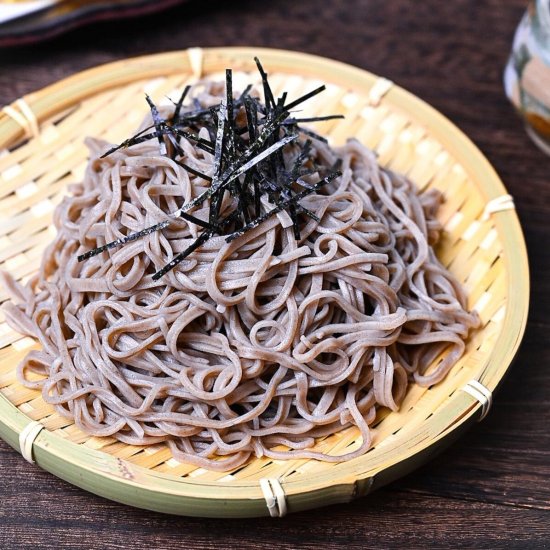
0, 0, 550, 549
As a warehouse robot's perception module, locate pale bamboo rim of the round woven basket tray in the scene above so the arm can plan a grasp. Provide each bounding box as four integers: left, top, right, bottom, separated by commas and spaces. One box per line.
0, 48, 529, 517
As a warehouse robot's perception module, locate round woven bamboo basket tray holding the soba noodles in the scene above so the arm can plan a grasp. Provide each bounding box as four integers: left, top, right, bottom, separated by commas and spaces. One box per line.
0, 48, 529, 517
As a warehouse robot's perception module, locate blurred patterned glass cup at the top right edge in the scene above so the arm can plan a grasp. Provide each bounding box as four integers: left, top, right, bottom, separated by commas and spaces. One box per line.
504, 0, 550, 155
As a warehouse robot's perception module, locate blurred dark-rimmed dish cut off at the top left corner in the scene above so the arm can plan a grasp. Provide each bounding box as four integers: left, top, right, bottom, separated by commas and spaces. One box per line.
0, 0, 185, 47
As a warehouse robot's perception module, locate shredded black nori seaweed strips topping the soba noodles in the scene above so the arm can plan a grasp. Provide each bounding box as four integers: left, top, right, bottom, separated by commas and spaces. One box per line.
78, 58, 343, 280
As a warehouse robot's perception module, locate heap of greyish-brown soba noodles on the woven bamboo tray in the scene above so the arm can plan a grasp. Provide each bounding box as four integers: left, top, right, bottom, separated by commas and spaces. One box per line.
2, 77, 478, 471
